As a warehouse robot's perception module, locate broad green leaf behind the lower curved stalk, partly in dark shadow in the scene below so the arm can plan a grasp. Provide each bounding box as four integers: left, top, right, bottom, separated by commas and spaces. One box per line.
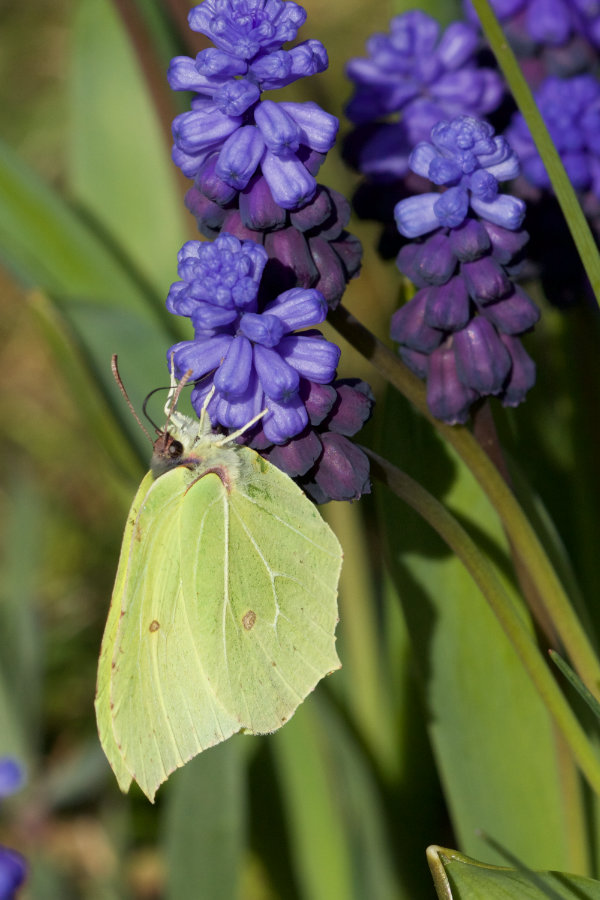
382, 395, 587, 869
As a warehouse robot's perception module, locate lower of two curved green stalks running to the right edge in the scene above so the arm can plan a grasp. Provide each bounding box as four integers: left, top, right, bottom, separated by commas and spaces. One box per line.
370, 448, 600, 796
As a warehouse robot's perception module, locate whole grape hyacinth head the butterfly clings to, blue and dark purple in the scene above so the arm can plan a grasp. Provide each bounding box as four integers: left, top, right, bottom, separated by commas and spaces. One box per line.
167, 233, 373, 503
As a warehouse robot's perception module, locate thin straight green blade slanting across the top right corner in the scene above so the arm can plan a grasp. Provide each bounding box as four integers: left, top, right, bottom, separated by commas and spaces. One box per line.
473, 0, 600, 303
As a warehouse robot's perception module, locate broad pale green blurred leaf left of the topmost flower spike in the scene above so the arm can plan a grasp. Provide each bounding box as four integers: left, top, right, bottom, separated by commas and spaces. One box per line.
69, 0, 186, 296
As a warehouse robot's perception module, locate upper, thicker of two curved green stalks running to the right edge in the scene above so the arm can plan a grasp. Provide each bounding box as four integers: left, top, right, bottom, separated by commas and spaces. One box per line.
328, 306, 600, 698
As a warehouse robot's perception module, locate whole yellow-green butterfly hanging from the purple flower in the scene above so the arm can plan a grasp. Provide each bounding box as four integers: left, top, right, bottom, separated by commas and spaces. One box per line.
95, 358, 342, 801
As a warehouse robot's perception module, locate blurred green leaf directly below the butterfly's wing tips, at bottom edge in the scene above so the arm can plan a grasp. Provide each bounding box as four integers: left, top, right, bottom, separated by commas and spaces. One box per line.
162, 739, 249, 900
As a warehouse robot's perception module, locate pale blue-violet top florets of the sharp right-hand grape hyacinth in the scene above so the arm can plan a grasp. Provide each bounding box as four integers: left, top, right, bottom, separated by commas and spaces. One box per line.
394, 116, 525, 238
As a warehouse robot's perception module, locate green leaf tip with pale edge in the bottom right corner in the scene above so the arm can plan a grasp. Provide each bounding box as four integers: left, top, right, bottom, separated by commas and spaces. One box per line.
427, 847, 600, 900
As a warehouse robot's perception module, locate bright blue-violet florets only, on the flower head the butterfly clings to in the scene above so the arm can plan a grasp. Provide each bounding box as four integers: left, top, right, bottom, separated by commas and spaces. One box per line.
167, 234, 340, 444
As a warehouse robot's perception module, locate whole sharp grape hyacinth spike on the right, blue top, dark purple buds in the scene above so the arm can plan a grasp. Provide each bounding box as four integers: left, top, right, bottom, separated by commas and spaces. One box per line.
391, 116, 539, 425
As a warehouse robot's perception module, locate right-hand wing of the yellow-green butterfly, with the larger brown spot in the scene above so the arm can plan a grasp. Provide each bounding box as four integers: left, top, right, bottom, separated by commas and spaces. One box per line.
182, 449, 342, 734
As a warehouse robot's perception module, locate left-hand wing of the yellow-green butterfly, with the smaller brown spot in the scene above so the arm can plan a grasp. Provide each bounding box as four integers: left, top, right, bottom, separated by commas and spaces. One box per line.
110, 467, 241, 800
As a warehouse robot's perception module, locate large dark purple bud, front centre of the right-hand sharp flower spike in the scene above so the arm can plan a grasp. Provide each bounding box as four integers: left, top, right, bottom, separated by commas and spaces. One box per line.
454, 316, 511, 394
